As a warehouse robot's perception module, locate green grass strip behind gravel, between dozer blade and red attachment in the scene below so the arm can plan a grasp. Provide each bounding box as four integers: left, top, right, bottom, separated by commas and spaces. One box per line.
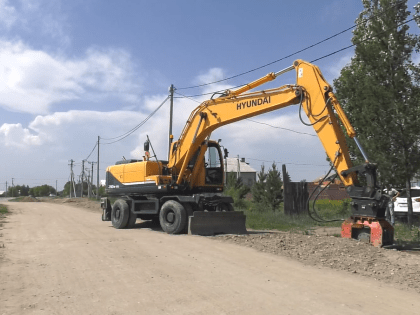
237, 200, 351, 233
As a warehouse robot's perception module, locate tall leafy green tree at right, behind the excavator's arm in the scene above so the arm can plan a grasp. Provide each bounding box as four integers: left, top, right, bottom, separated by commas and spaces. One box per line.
334, 0, 420, 226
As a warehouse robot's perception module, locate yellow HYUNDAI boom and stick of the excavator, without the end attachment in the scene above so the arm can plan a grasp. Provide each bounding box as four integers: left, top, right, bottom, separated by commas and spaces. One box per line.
168, 60, 356, 186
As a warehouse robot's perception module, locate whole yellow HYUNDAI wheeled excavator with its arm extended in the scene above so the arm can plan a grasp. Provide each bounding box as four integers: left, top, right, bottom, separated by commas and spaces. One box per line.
101, 60, 394, 246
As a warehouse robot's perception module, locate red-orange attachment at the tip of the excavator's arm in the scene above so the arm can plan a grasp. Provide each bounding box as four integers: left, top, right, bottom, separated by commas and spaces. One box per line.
341, 216, 394, 247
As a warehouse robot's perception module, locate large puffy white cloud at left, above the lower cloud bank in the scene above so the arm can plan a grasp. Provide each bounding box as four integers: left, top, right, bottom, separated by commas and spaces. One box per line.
0, 41, 139, 114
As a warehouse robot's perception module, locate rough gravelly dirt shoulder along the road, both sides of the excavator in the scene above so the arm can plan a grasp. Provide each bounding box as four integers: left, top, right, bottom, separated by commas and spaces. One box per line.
44, 198, 420, 293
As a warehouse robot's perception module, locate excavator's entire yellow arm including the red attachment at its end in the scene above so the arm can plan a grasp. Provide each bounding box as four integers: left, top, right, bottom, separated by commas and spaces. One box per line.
168, 60, 393, 246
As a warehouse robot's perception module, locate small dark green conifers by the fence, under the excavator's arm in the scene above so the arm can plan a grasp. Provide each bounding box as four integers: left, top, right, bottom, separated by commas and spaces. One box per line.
252, 163, 283, 212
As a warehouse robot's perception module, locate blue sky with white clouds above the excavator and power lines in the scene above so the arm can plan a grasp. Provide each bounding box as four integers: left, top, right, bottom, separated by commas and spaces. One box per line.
0, 0, 417, 190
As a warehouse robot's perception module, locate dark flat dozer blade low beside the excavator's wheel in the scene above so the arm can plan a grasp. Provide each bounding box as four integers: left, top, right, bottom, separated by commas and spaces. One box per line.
188, 211, 247, 236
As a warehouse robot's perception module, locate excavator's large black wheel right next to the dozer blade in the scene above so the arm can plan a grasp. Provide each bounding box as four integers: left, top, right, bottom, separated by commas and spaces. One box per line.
159, 200, 187, 234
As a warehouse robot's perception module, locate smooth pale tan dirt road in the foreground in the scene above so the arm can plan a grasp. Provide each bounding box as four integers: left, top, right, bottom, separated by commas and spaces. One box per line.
0, 202, 420, 314
